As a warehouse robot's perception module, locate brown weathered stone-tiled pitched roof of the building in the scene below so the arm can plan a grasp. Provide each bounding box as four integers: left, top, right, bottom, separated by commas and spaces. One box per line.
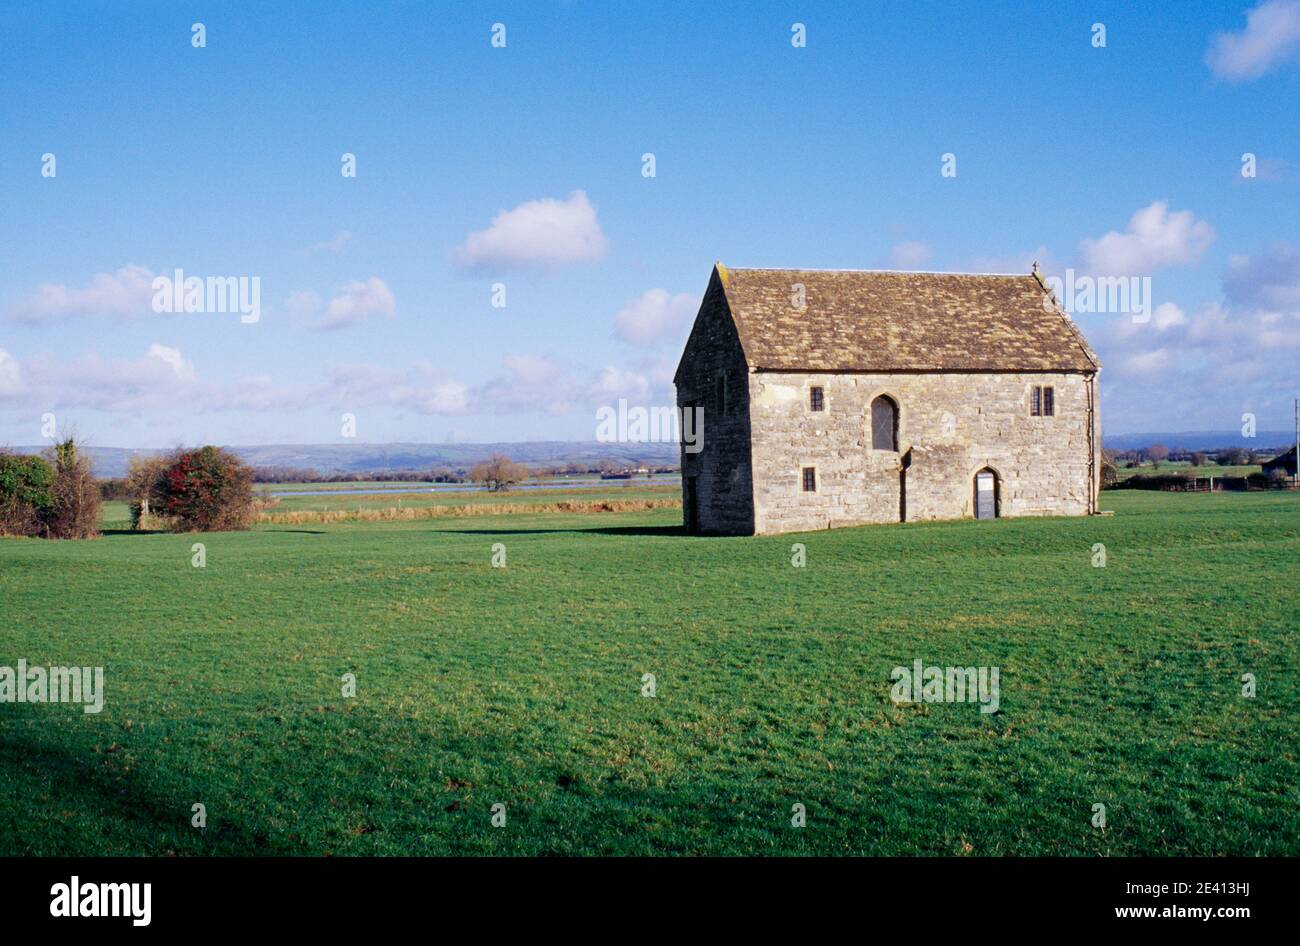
715, 262, 1101, 372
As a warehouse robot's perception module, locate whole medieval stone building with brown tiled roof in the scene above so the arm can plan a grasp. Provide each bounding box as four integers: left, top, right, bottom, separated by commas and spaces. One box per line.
673, 262, 1101, 535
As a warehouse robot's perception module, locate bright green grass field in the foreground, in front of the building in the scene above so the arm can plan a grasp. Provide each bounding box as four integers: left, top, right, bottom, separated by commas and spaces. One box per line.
0, 492, 1300, 855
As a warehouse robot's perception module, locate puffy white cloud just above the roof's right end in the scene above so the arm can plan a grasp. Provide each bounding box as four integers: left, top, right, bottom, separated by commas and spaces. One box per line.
1079, 200, 1214, 275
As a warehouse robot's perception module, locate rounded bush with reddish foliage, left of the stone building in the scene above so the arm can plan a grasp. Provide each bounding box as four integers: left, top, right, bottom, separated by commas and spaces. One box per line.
157, 447, 257, 531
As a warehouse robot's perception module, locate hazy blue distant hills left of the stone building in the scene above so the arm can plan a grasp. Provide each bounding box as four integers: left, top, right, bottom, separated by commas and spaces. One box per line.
10, 441, 680, 477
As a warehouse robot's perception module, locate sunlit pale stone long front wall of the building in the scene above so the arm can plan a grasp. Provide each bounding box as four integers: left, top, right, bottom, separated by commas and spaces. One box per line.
749, 372, 1100, 533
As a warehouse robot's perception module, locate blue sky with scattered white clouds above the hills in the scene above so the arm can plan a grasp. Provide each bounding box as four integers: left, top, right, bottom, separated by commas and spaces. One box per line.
0, 0, 1300, 447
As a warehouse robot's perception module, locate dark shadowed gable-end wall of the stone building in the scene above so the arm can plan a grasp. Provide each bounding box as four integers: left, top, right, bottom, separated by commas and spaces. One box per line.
676, 274, 754, 535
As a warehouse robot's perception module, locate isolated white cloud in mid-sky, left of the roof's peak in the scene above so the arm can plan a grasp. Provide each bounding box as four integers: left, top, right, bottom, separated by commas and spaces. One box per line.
455, 191, 608, 268
